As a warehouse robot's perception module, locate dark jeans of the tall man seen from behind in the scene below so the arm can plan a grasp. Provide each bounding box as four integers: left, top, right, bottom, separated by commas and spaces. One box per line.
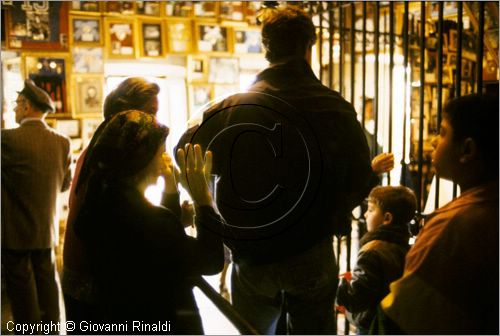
231, 239, 338, 335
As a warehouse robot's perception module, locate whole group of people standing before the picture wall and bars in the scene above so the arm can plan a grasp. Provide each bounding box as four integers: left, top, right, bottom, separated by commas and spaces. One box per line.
1, 6, 499, 334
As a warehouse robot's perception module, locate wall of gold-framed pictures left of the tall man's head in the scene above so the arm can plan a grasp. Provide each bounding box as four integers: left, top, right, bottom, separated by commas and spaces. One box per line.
2, 1, 266, 145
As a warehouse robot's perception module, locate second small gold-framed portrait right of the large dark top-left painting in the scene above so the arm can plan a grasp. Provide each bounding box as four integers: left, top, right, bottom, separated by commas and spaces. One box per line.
105, 18, 136, 58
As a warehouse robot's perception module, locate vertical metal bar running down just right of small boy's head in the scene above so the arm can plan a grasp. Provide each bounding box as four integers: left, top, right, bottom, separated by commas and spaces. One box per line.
417, 1, 425, 212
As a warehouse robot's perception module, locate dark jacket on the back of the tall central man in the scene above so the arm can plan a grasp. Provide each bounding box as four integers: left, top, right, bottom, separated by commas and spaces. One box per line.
182, 59, 370, 263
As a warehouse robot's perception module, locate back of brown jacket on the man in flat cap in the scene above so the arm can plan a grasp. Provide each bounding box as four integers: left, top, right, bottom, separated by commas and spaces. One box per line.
2, 120, 71, 249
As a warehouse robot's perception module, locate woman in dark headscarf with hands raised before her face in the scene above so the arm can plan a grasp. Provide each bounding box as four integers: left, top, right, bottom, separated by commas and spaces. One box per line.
75, 110, 223, 334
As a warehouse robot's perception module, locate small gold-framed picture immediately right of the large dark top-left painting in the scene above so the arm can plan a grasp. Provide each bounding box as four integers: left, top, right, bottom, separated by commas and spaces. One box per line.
70, 16, 102, 46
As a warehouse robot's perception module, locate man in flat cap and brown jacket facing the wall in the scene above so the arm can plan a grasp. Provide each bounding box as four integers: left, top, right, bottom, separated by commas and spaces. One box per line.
1, 80, 71, 323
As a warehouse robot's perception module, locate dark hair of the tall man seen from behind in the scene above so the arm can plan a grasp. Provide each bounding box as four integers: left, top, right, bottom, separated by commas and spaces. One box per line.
261, 6, 316, 63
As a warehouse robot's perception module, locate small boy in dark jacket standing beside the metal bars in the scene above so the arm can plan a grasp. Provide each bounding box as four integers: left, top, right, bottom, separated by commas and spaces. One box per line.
337, 186, 417, 334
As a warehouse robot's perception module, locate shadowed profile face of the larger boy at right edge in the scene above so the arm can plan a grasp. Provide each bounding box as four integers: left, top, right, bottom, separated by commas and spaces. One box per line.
432, 118, 459, 180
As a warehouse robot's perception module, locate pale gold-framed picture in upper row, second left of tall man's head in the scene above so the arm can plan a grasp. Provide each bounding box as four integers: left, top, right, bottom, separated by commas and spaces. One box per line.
195, 23, 230, 53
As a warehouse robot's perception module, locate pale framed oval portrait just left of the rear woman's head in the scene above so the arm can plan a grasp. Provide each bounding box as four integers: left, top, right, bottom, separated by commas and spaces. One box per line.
73, 75, 104, 118
